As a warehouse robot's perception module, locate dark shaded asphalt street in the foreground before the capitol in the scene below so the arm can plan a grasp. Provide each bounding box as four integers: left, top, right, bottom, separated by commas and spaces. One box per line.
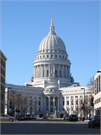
1, 119, 100, 134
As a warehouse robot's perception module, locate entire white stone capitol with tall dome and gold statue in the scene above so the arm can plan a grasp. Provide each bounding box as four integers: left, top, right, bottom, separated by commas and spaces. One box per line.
5, 19, 94, 118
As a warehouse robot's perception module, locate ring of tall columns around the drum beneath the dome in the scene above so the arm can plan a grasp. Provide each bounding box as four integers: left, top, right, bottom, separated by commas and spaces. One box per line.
34, 64, 70, 78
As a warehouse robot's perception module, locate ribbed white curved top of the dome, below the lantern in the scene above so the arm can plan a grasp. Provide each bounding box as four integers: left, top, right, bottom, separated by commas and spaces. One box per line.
38, 33, 66, 52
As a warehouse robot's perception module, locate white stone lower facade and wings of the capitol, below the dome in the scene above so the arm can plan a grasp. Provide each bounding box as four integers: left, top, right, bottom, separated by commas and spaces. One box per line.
6, 84, 93, 117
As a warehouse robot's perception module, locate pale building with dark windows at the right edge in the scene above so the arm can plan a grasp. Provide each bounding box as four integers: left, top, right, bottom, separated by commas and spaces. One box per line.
94, 69, 101, 115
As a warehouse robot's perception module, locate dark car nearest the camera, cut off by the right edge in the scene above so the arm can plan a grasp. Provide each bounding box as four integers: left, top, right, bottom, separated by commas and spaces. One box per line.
88, 115, 101, 128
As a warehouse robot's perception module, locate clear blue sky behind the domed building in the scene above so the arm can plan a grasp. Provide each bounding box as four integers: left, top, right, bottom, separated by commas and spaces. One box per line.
0, 0, 101, 85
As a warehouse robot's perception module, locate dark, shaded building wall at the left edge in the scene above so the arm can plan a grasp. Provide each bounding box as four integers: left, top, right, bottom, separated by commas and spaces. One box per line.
0, 50, 7, 113
